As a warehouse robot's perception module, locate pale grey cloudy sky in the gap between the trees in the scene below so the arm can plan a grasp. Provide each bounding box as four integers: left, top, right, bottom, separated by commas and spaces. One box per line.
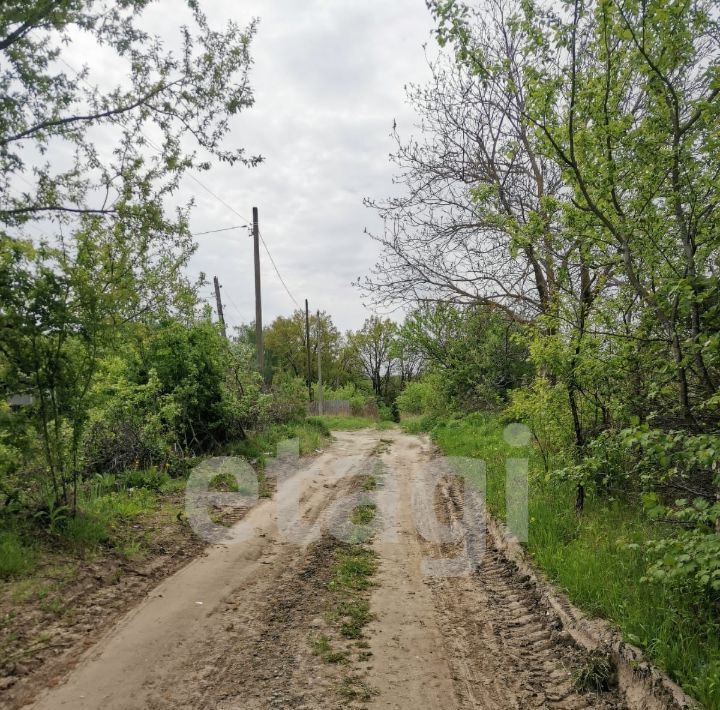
167, 0, 433, 329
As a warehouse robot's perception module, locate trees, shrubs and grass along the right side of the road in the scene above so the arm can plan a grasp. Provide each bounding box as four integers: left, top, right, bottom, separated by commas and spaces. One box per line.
372, 0, 720, 708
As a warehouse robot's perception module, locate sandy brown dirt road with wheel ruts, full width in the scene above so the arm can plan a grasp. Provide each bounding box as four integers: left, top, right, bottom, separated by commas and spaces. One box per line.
25, 430, 622, 710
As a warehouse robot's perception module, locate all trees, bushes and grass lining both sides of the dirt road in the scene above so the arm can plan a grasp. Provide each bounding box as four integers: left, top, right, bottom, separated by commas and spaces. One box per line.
0, 0, 720, 708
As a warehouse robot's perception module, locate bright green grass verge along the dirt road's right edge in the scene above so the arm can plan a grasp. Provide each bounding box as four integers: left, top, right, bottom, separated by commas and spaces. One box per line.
424, 414, 720, 708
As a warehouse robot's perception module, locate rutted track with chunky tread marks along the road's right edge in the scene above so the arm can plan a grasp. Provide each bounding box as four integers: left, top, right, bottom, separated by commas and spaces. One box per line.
423, 468, 623, 710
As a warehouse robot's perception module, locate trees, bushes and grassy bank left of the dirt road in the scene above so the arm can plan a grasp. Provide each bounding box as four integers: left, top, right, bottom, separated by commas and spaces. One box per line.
0, 0, 400, 692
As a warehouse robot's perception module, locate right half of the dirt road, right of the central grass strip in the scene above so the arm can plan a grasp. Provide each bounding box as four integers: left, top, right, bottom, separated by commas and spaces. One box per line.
369, 433, 625, 710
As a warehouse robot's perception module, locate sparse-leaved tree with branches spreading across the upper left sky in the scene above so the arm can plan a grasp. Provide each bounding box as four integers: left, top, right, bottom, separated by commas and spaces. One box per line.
0, 0, 258, 506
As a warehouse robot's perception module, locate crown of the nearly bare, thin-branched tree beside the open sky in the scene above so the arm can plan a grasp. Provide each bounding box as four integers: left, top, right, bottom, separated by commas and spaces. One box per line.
359, 7, 574, 322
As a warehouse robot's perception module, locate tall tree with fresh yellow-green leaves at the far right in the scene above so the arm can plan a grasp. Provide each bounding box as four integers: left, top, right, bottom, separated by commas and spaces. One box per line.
433, 0, 720, 428
